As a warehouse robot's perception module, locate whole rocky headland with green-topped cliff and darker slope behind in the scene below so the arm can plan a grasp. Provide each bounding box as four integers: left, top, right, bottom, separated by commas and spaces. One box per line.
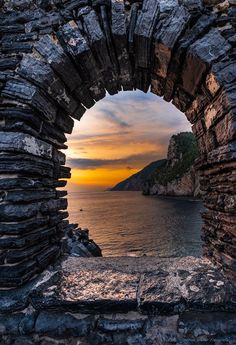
110, 132, 199, 196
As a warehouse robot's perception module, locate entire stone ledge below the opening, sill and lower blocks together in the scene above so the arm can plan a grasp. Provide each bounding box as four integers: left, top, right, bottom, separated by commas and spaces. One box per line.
0, 257, 236, 345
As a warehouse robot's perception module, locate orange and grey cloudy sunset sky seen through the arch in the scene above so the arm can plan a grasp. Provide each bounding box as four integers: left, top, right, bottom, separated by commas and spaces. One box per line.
66, 91, 191, 192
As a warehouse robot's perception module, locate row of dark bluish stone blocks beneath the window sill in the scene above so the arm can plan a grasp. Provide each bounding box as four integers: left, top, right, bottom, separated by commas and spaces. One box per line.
0, 312, 236, 345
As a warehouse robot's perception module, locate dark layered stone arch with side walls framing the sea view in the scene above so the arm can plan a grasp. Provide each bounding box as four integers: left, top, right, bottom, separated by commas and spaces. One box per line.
0, 0, 236, 288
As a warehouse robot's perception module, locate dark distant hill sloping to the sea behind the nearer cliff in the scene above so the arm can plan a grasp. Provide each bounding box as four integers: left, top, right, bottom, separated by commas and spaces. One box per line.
109, 159, 166, 191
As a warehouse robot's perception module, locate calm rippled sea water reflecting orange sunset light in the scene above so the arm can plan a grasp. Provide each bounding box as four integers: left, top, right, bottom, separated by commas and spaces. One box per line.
68, 192, 203, 257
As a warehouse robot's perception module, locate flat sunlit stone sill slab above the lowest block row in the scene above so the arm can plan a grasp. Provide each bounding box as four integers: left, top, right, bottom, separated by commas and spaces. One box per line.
0, 257, 236, 315
